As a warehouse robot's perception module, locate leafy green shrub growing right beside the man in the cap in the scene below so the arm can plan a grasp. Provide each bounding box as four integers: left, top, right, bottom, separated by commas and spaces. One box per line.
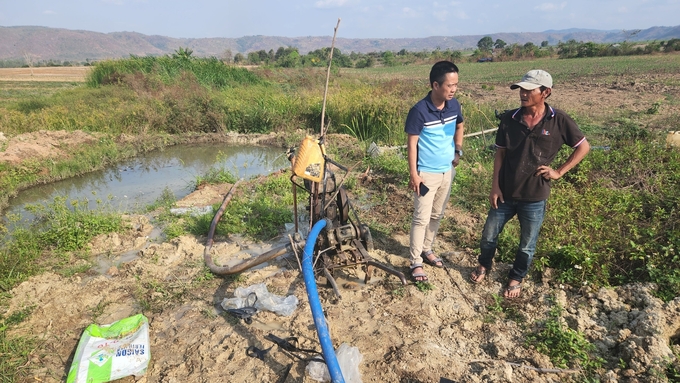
537, 136, 680, 300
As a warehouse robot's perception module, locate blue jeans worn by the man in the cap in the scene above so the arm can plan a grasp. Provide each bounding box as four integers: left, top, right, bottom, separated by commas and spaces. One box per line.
478, 200, 546, 282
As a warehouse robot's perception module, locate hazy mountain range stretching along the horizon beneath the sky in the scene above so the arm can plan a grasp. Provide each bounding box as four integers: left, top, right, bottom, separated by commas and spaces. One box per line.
0, 25, 680, 62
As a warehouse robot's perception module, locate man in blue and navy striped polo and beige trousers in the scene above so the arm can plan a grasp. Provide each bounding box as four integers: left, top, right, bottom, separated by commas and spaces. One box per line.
404, 61, 464, 282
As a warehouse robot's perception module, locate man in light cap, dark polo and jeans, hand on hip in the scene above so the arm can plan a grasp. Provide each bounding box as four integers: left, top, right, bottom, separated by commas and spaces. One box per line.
470, 69, 590, 298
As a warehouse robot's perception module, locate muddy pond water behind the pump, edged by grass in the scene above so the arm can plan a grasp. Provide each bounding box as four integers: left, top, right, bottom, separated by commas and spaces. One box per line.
3, 144, 290, 221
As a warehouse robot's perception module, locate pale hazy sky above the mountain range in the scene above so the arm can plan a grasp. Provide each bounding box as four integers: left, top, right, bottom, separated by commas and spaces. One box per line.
0, 0, 680, 38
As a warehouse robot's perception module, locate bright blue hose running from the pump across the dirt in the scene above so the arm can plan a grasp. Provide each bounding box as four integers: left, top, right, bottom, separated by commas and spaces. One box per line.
302, 219, 345, 383
